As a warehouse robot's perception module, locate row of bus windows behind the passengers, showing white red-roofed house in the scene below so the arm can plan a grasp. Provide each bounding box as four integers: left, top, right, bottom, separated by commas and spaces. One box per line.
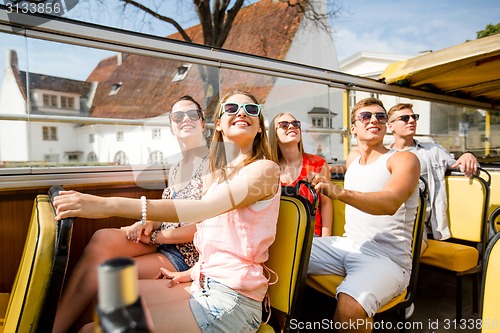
0, 25, 500, 167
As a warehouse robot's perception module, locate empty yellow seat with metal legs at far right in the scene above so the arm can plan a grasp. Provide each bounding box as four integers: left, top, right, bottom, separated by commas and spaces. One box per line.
420, 169, 491, 320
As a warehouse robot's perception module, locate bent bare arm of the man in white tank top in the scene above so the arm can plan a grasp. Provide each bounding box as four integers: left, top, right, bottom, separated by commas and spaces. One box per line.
309, 152, 420, 215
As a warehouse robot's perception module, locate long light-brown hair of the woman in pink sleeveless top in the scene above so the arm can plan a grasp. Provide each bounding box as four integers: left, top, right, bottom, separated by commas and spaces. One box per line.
210, 90, 271, 183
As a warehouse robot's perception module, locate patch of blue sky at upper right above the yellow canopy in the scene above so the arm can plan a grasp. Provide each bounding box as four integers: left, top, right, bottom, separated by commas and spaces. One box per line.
332, 0, 500, 60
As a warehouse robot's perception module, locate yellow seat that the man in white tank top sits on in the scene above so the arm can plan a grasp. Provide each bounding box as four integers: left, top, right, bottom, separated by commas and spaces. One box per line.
307, 178, 427, 331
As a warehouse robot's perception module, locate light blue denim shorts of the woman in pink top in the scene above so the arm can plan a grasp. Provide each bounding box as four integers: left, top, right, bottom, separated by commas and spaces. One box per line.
189, 277, 262, 333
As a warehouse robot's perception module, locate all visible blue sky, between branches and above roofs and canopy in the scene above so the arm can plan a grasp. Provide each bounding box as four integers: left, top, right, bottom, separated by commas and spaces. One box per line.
0, 0, 500, 81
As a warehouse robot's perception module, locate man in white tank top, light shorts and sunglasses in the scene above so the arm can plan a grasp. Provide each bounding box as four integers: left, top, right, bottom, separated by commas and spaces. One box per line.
308, 98, 420, 332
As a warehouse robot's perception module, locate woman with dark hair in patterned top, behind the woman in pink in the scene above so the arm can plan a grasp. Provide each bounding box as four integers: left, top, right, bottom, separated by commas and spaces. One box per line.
53, 95, 208, 332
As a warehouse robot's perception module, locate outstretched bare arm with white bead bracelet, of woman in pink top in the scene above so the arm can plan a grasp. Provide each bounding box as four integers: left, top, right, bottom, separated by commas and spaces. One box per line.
54, 160, 279, 223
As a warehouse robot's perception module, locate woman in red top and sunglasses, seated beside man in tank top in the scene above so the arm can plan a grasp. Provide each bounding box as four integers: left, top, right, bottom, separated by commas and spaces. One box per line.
269, 113, 333, 236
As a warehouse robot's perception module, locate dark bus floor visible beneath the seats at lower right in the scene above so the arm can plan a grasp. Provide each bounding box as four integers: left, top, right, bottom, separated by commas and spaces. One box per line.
294, 265, 481, 333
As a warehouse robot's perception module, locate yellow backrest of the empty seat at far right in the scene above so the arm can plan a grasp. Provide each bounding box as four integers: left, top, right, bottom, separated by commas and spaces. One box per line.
445, 171, 490, 243
